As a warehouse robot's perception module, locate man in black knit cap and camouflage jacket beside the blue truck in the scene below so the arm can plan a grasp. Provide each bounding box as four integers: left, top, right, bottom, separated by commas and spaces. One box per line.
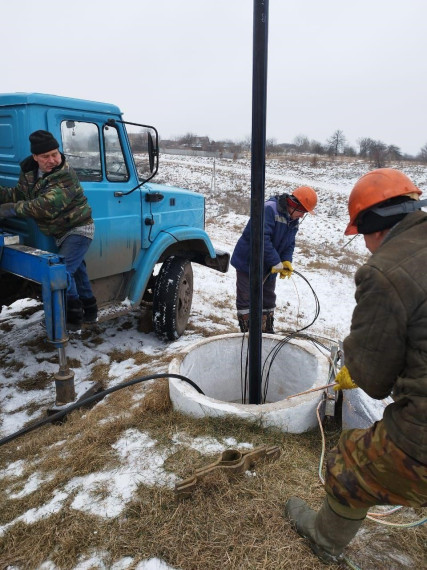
0, 126, 97, 330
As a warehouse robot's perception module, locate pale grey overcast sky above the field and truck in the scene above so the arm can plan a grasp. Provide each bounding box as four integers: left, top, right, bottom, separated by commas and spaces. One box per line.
0, 0, 427, 154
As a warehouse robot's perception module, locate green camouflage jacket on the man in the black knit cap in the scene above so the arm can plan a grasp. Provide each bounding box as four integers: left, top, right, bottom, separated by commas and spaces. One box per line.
0, 155, 93, 238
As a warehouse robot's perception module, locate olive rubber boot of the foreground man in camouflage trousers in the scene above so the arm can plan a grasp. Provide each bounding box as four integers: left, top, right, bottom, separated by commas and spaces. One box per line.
285, 497, 366, 564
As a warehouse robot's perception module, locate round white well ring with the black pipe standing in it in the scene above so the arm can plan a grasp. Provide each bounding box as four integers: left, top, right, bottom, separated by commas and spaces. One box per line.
169, 333, 329, 433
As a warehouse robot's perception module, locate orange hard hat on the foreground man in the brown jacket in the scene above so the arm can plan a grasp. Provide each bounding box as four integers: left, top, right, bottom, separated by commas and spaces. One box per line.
344, 168, 422, 235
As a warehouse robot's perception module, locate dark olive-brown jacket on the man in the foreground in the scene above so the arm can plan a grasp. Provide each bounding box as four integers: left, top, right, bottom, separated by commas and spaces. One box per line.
344, 211, 427, 464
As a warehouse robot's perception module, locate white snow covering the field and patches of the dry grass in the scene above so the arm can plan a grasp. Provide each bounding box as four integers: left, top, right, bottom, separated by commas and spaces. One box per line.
0, 155, 427, 570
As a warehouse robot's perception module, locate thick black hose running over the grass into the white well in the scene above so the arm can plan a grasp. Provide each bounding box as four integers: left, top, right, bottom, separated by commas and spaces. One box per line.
0, 373, 205, 446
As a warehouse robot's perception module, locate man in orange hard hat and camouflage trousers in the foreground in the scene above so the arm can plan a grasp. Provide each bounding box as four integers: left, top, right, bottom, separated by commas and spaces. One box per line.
285, 168, 427, 563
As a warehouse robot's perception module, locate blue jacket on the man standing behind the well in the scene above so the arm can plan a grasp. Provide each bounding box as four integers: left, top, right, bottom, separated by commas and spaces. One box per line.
230, 196, 299, 278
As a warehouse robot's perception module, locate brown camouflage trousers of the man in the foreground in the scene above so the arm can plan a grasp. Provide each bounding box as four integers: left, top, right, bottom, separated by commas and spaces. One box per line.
325, 414, 427, 518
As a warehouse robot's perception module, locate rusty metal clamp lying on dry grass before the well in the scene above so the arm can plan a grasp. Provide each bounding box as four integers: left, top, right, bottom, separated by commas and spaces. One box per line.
175, 445, 280, 499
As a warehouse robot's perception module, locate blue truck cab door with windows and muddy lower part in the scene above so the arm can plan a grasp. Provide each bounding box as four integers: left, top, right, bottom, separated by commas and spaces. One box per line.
52, 110, 141, 279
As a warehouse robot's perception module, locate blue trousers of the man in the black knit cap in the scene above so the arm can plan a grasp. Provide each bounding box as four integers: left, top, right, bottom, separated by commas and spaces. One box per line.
58, 234, 93, 299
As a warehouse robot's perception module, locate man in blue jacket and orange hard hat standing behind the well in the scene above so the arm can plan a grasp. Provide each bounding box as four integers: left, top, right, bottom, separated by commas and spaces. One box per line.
231, 186, 317, 334
